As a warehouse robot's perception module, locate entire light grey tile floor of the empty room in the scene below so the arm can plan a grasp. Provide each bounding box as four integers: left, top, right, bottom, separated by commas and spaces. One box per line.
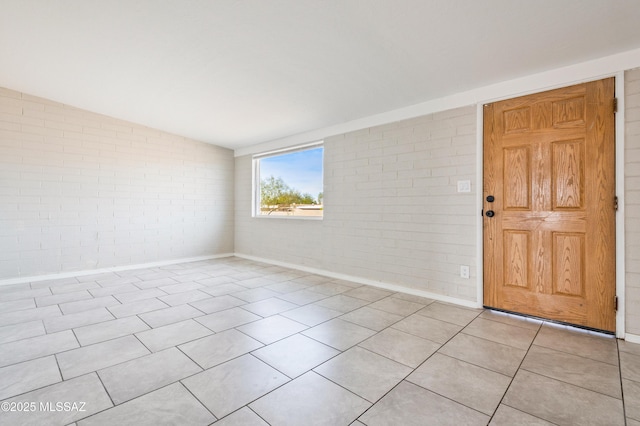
0, 258, 640, 426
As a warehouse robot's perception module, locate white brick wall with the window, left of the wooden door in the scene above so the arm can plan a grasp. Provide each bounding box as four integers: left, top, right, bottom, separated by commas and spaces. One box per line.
235, 106, 478, 300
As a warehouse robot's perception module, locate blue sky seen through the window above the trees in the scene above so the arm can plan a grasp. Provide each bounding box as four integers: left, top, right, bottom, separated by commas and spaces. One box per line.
260, 147, 323, 199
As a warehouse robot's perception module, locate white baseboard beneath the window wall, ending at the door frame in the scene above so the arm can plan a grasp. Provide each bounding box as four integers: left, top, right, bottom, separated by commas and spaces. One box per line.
234, 253, 482, 308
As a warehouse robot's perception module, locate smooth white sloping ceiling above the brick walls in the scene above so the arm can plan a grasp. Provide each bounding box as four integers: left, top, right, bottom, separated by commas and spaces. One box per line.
0, 0, 640, 149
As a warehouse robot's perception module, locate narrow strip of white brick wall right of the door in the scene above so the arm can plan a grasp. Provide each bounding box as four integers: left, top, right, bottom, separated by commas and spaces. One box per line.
624, 69, 640, 335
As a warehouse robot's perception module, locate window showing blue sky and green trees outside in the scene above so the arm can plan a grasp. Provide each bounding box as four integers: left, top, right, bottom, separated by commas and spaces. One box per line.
253, 142, 324, 218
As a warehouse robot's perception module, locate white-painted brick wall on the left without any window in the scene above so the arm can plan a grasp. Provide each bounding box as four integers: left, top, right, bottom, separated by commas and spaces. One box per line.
0, 88, 234, 279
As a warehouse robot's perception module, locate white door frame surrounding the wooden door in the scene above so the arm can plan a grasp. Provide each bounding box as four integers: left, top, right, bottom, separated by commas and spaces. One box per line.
475, 71, 625, 339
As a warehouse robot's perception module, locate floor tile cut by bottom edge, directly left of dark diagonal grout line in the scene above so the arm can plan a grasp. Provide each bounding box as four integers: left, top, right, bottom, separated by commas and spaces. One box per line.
360, 381, 489, 426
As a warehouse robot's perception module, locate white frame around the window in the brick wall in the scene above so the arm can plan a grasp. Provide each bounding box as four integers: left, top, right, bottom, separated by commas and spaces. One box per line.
251, 140, 324, 220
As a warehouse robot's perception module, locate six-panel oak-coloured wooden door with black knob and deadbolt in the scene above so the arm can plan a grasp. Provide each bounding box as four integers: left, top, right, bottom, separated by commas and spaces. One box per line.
483, 78, 615, 331
